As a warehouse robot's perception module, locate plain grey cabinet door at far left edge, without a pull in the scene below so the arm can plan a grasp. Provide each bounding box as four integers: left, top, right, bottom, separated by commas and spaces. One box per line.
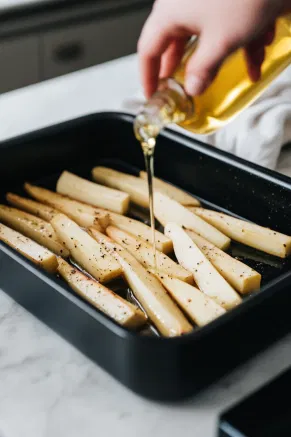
0, 36, 39, 93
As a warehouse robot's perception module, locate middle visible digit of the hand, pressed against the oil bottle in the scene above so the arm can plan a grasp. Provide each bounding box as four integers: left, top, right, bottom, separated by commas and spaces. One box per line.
185, 35, 236, 96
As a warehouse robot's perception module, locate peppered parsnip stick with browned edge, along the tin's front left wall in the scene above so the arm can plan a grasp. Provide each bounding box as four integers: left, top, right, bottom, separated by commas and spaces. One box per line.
58, 259, 147, 328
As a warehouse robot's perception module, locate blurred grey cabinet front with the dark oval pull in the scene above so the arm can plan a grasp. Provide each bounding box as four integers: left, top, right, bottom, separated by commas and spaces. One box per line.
43, 8, 150, 79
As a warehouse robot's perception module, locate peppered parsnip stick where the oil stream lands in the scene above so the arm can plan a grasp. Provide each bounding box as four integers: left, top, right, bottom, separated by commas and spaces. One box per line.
106, 226, 193, 284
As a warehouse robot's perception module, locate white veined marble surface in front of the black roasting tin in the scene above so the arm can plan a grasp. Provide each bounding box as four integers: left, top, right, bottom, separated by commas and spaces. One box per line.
0, 284, 291, 437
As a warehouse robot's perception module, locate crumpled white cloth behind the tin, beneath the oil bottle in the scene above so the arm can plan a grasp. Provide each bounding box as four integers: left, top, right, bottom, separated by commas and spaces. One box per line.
123, 67, 291, 169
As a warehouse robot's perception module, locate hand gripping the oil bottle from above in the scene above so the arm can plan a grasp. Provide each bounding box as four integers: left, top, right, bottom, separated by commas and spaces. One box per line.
138, 0, 291, 98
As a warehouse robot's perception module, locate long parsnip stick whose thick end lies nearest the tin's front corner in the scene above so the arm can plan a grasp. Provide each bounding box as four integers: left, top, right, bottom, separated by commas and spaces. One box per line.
90, 228, 193, 337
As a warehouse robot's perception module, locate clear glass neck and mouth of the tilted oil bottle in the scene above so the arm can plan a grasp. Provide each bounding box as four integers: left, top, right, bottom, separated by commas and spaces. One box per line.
134, 78, 194, 148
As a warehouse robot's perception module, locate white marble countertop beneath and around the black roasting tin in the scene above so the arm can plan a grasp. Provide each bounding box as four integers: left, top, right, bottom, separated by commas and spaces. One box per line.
0, 56, 291, 437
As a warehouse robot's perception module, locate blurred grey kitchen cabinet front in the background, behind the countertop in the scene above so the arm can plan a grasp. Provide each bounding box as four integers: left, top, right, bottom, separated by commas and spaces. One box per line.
0, 0, 152, 93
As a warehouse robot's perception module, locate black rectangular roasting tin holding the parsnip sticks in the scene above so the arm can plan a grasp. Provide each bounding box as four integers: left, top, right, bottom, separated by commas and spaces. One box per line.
0, 112, 291, 402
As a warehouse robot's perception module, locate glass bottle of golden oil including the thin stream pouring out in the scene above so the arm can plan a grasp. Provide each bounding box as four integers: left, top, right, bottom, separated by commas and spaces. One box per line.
134, 15, 291, 258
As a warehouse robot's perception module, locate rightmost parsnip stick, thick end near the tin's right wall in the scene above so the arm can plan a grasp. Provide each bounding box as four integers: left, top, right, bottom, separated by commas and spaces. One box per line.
193, 208, 291, 258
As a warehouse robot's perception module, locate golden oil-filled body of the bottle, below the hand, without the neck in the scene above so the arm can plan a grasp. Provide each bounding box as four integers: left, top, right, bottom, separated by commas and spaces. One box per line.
174, 15, 291, 135
